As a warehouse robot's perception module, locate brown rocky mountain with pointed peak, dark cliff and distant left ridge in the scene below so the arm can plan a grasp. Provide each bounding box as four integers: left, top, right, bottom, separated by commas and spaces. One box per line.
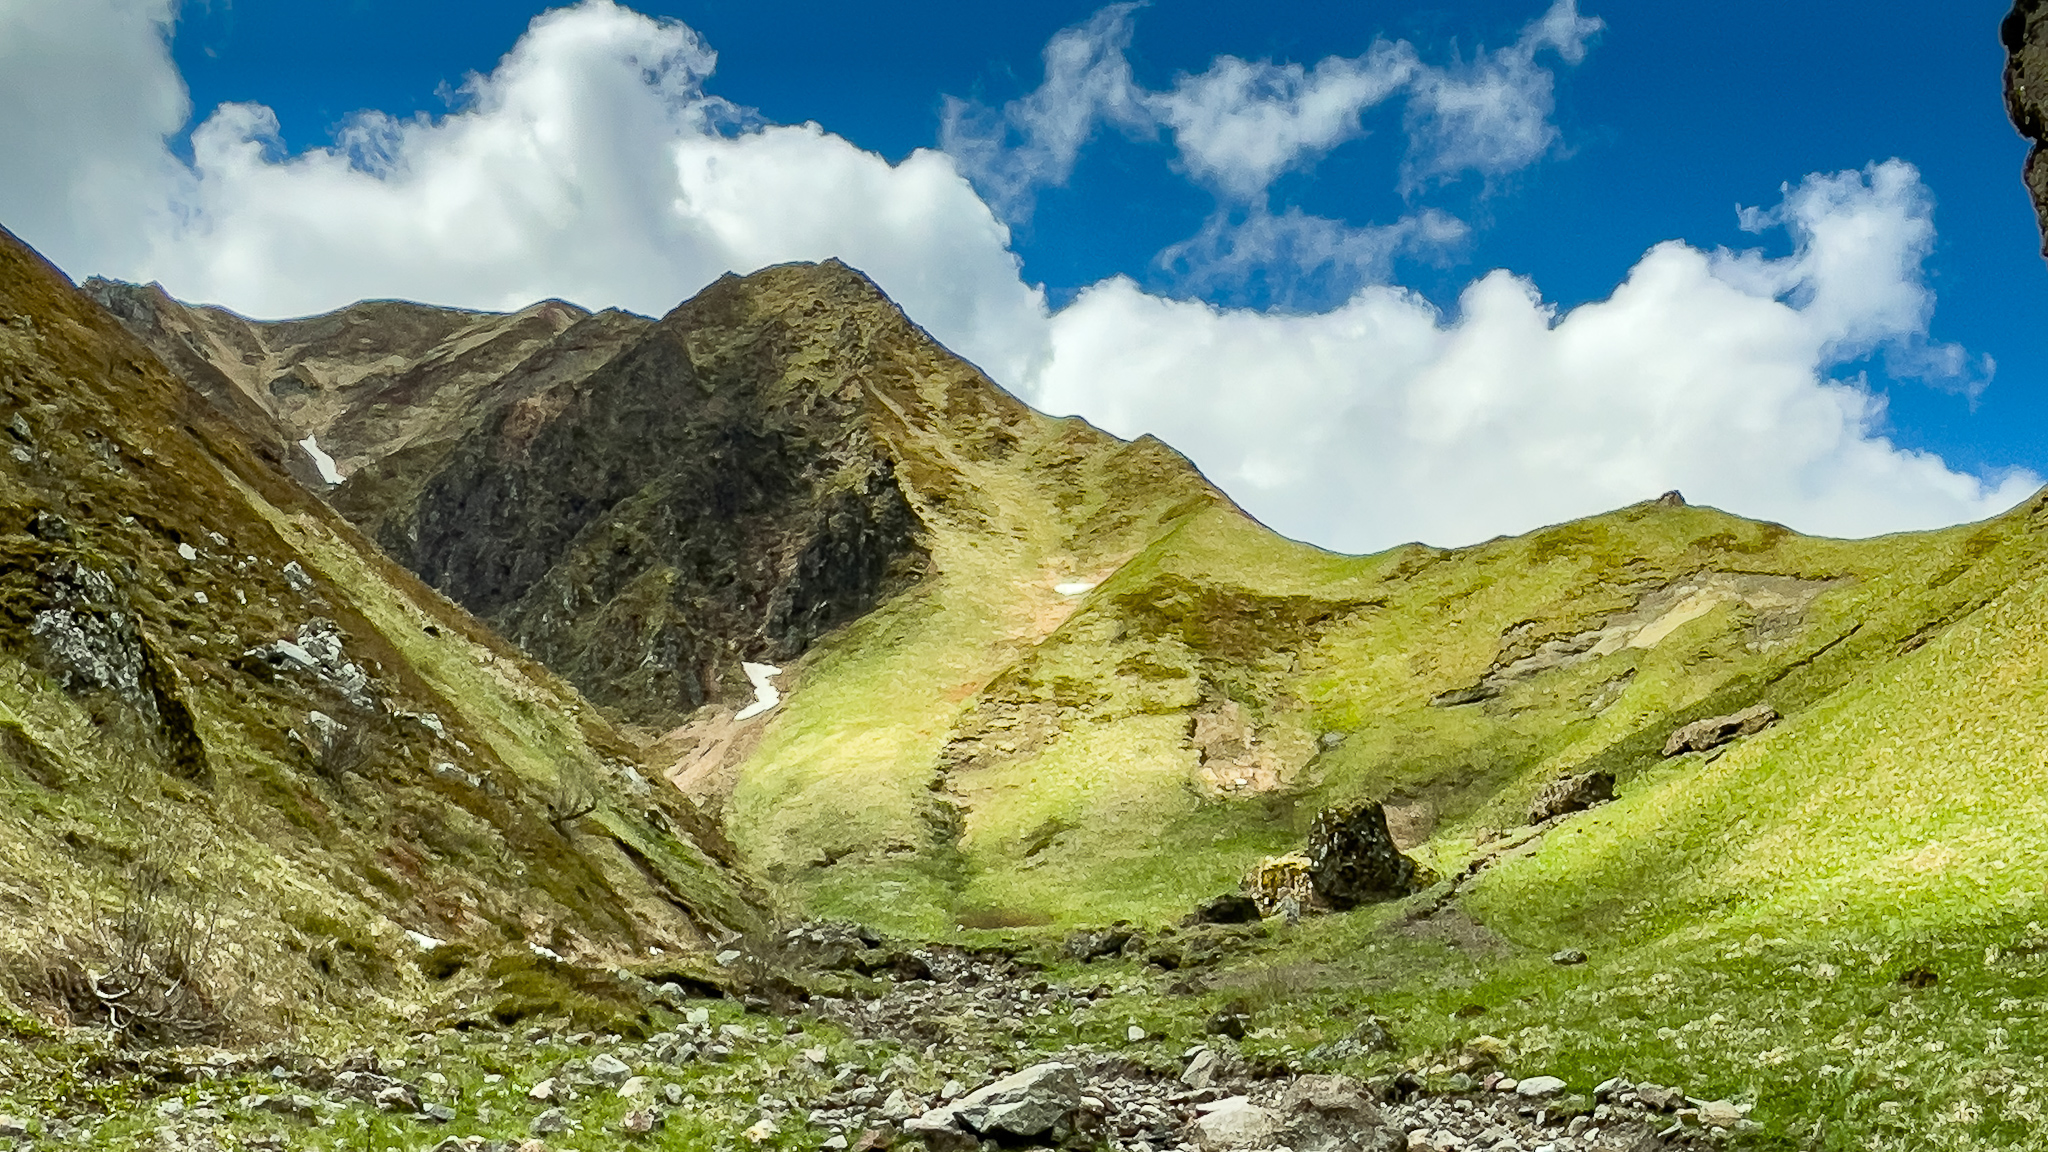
108, 262, 1221, 729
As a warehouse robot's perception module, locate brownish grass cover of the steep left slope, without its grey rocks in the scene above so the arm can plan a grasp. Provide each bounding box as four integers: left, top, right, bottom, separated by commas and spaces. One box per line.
0, 236, 754, 1031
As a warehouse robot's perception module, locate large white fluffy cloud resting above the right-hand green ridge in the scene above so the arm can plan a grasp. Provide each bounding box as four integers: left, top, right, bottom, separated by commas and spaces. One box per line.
1036, 160, 2040, 549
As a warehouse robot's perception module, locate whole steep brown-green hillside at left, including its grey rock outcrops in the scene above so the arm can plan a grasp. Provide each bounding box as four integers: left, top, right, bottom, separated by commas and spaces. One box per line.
0, 224, 758, 1039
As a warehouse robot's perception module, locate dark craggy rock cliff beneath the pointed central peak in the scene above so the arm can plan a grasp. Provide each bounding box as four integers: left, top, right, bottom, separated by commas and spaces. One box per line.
393, 264, 924, 724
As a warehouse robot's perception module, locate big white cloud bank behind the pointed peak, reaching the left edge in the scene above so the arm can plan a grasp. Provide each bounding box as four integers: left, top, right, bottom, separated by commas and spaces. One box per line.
0, 0, 1044, 379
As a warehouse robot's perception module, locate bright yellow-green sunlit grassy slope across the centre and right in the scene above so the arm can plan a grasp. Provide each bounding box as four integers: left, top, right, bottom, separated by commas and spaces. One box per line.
739, 393, 2048, 1148
